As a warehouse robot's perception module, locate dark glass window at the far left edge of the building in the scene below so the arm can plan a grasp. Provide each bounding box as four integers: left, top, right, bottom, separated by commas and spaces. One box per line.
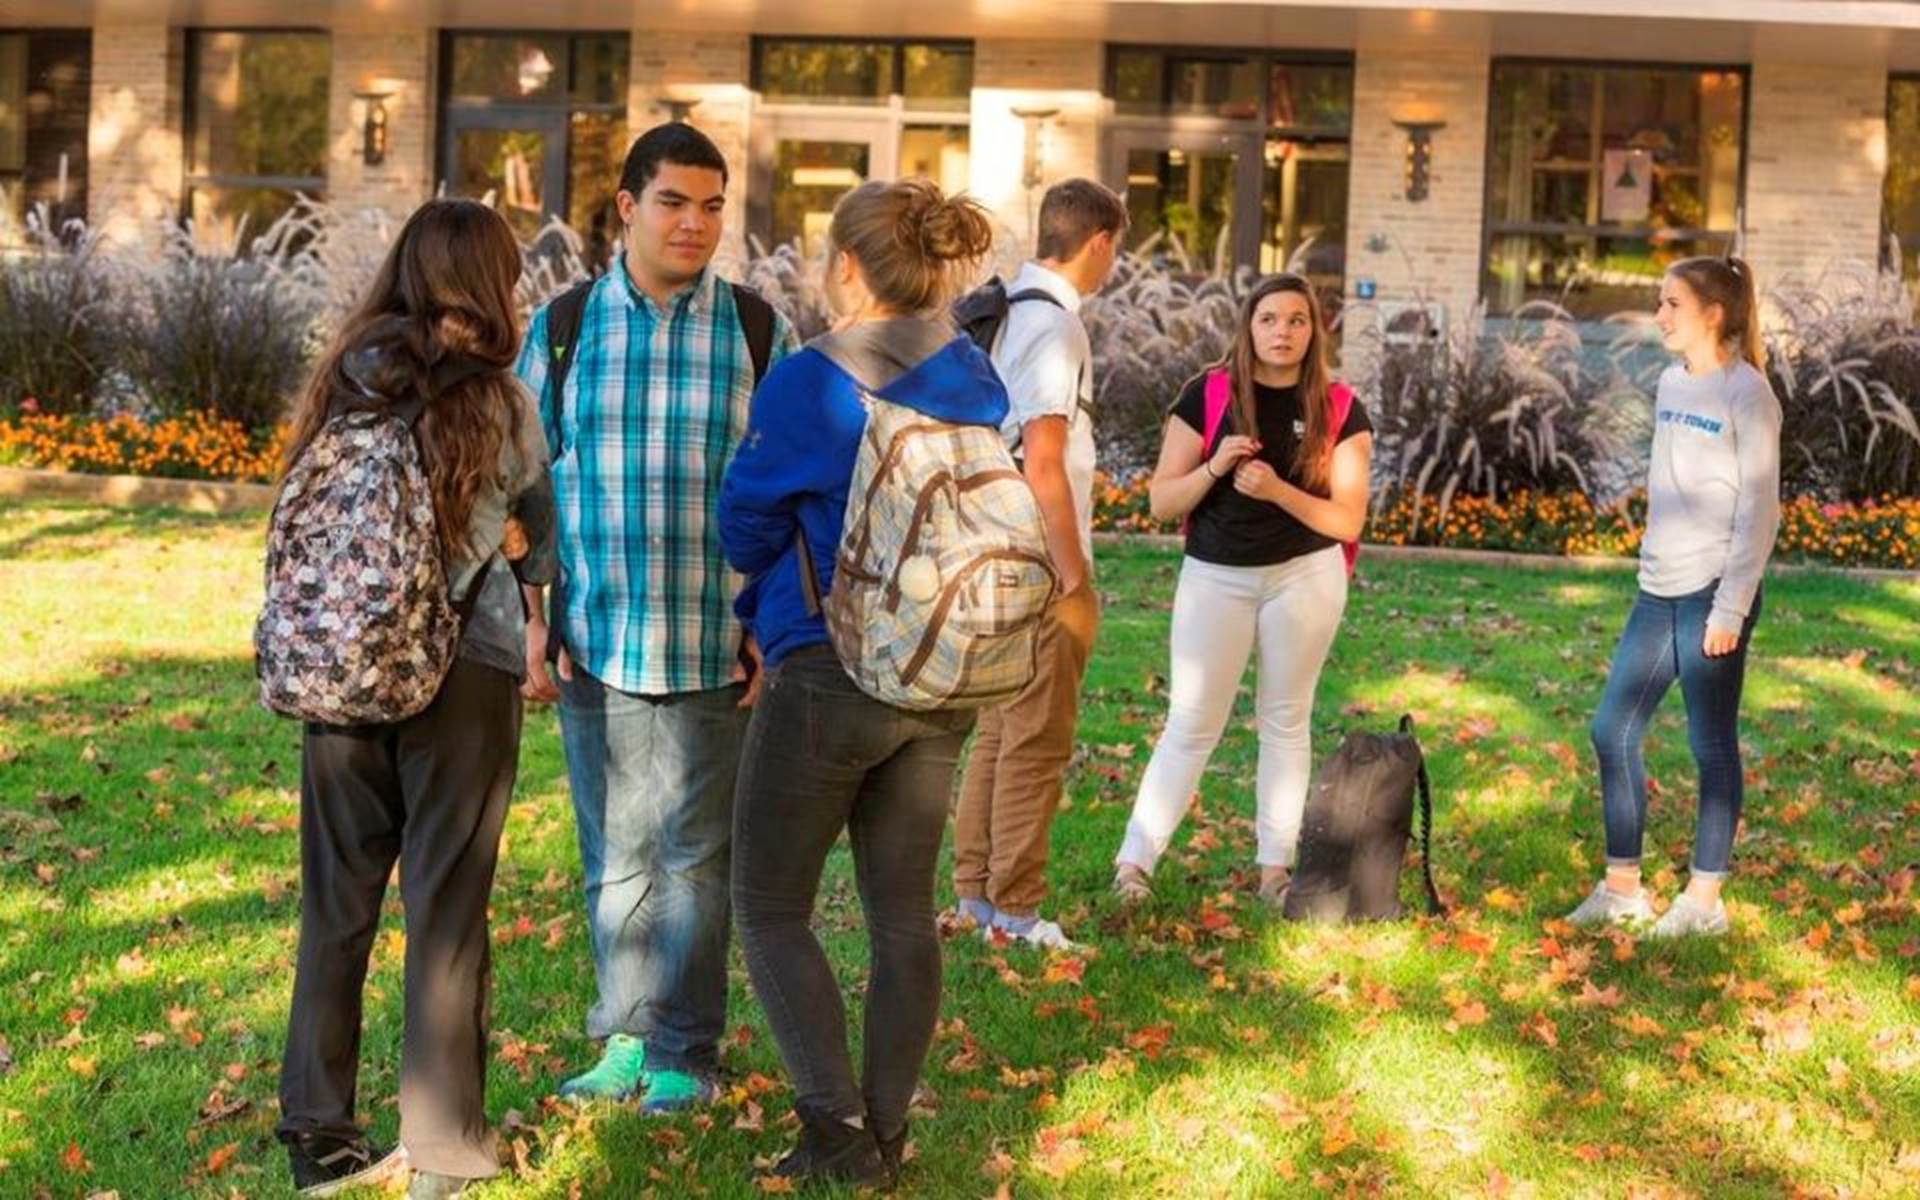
0, 31, 92, 246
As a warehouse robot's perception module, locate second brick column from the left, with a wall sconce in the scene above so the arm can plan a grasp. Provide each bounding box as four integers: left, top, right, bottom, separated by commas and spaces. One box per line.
326, 29, 434, 219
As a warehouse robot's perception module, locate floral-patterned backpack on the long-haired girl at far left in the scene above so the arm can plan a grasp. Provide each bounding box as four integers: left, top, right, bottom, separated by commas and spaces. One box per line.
253, 399, 458, 726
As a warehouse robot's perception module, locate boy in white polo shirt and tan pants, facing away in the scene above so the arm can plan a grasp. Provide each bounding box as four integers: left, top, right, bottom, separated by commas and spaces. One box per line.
954, 179, 1127, 947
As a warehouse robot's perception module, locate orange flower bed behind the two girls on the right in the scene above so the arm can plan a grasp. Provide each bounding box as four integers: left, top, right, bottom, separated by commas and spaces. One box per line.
1094, 476, 1920, 570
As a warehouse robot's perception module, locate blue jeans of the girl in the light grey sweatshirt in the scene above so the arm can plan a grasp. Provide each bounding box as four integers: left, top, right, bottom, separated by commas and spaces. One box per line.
1592, 582, 1761, 877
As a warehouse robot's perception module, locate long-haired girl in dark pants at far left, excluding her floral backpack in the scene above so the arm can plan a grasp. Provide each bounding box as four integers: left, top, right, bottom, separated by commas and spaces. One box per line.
278, 200, 553, 1198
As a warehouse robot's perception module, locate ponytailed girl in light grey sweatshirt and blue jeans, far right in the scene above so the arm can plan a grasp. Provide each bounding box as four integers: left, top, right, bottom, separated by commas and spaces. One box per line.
1567, 257, 1780, 937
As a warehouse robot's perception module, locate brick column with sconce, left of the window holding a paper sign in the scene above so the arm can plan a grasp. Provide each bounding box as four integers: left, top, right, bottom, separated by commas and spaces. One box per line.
1346, 46, 1488, 321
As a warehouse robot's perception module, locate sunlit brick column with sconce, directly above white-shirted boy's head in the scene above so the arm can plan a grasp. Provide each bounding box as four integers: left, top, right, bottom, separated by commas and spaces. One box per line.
970, 40, 1104, 259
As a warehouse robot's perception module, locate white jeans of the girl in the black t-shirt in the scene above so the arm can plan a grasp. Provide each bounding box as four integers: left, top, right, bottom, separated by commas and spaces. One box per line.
1116, 545, 1346, 870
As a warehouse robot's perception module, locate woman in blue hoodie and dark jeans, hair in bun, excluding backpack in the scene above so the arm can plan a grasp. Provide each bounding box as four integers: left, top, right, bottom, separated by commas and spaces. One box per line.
720, 179, 1008, 1187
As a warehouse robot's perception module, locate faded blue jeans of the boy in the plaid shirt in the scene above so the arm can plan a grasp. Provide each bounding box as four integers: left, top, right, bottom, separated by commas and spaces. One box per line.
559, 666, 747, 1071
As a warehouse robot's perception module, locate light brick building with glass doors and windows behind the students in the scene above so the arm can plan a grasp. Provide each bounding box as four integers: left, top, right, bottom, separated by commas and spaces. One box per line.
0, 0, 1920, 332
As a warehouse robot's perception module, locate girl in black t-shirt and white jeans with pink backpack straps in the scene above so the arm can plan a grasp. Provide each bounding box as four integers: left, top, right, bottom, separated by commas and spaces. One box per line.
1114, 275, 1373, 902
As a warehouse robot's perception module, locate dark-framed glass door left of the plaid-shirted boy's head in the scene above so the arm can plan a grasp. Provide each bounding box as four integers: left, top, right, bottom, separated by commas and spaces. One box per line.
444, 106, 566, 240
